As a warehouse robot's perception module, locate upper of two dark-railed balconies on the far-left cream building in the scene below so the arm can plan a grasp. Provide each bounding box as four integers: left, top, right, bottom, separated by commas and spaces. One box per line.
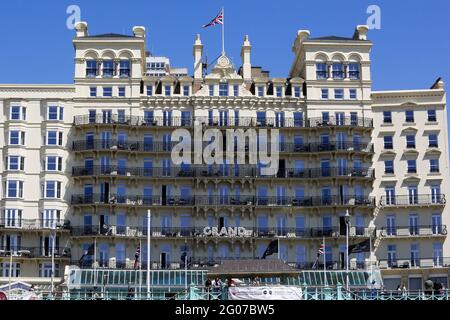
0, 218, 70, 230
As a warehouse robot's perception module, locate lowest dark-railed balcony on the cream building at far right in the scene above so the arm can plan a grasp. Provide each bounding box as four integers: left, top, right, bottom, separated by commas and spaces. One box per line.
378, 257, 450, 269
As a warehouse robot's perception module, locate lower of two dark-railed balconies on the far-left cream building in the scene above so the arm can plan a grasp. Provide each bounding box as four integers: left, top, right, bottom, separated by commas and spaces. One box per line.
0, 247, 71, 260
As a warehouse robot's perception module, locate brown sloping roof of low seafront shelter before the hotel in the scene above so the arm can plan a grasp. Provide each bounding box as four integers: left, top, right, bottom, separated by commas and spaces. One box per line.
208, 259, 299, 276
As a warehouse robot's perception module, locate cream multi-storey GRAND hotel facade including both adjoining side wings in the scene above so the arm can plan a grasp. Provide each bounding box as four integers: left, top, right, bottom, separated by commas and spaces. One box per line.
0, 23, 450, 289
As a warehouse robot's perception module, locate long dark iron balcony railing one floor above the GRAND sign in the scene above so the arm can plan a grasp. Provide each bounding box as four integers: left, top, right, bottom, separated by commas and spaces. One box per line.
71, 194, 375, 207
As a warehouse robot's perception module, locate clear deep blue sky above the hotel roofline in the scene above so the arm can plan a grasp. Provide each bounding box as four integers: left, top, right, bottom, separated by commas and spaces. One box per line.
0, 0, 450, 90
